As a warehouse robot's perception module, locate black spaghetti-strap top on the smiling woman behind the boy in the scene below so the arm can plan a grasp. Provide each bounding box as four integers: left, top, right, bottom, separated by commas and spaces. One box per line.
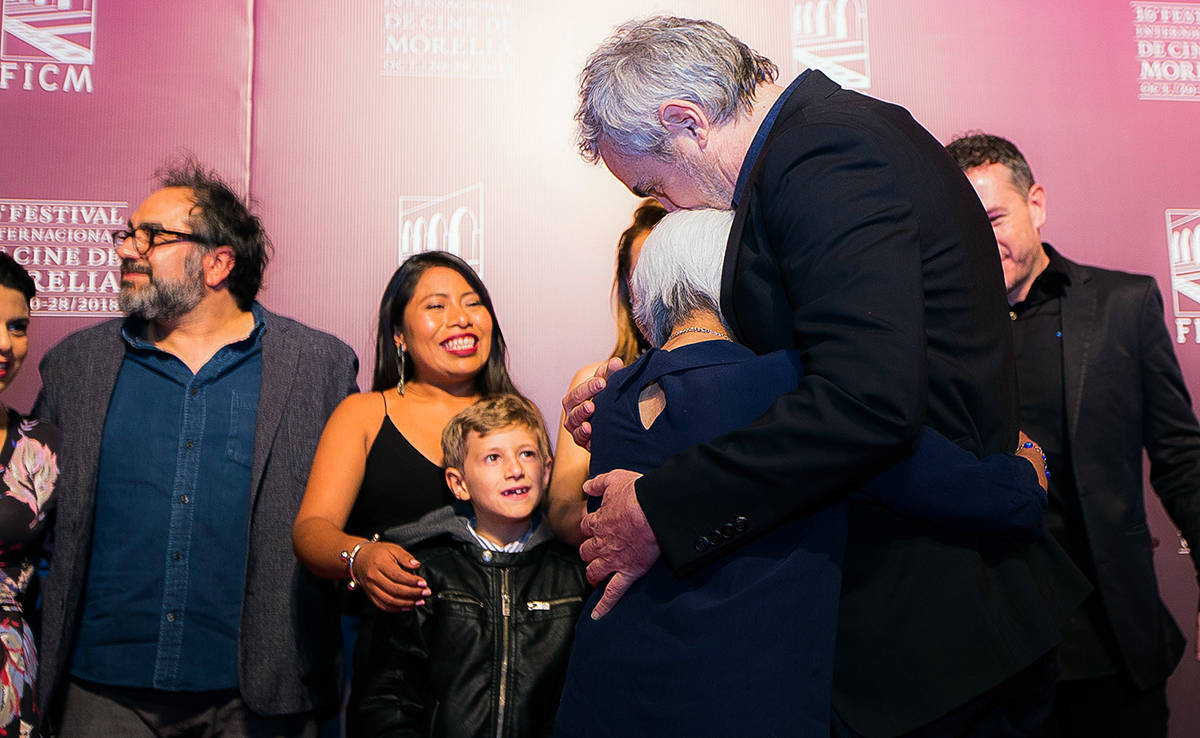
346, 392, 451, 538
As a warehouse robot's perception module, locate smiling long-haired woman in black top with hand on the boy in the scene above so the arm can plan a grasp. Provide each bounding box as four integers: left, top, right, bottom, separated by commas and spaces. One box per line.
292, 251, 516, 611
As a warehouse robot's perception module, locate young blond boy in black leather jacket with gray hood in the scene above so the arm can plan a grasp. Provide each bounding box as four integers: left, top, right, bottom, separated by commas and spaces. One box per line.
347, 395, 588, 737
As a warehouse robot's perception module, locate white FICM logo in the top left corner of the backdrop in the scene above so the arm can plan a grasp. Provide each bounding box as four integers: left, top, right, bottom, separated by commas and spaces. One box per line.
0, 0, 96, 92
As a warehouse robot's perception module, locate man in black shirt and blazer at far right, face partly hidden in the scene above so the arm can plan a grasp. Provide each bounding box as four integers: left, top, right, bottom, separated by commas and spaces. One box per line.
947, 134, 1200, 737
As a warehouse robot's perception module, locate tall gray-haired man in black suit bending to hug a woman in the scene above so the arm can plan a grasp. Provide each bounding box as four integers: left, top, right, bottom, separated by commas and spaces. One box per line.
564, 17, 1086, 738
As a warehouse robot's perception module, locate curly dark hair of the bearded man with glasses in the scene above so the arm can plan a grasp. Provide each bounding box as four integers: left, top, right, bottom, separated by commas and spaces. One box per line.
157, 156, 271, 310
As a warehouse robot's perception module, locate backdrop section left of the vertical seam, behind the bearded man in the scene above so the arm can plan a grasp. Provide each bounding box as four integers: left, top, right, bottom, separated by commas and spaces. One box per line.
0, 0, 253, 386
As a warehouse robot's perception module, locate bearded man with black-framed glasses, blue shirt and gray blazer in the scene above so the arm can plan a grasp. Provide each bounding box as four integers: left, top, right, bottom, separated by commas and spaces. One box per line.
28, 161, 356, 738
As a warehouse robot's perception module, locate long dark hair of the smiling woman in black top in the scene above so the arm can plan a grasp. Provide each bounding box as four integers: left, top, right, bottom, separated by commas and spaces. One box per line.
371, 251, 520, 396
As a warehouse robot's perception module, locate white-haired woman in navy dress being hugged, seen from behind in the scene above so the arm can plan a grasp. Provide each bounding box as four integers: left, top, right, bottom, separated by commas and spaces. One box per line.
556, 210, 1060, 738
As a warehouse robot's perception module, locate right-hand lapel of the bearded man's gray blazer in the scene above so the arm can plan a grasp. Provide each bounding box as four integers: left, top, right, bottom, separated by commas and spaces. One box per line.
250, 310, 300, 510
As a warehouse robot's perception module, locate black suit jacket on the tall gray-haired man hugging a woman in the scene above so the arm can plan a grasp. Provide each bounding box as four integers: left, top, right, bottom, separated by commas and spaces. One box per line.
637, 71, 1086, 737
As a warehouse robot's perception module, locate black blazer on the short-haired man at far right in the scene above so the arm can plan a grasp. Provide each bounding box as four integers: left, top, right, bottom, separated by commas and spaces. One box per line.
1046, 246, 1200, 689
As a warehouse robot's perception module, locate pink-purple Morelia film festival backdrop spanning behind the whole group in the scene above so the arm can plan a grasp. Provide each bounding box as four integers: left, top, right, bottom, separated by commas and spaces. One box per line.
0, 0, 1200, 736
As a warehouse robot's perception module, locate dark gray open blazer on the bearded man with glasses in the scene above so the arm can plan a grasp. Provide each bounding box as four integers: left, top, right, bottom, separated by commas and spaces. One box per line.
34, 304, 358, 719
